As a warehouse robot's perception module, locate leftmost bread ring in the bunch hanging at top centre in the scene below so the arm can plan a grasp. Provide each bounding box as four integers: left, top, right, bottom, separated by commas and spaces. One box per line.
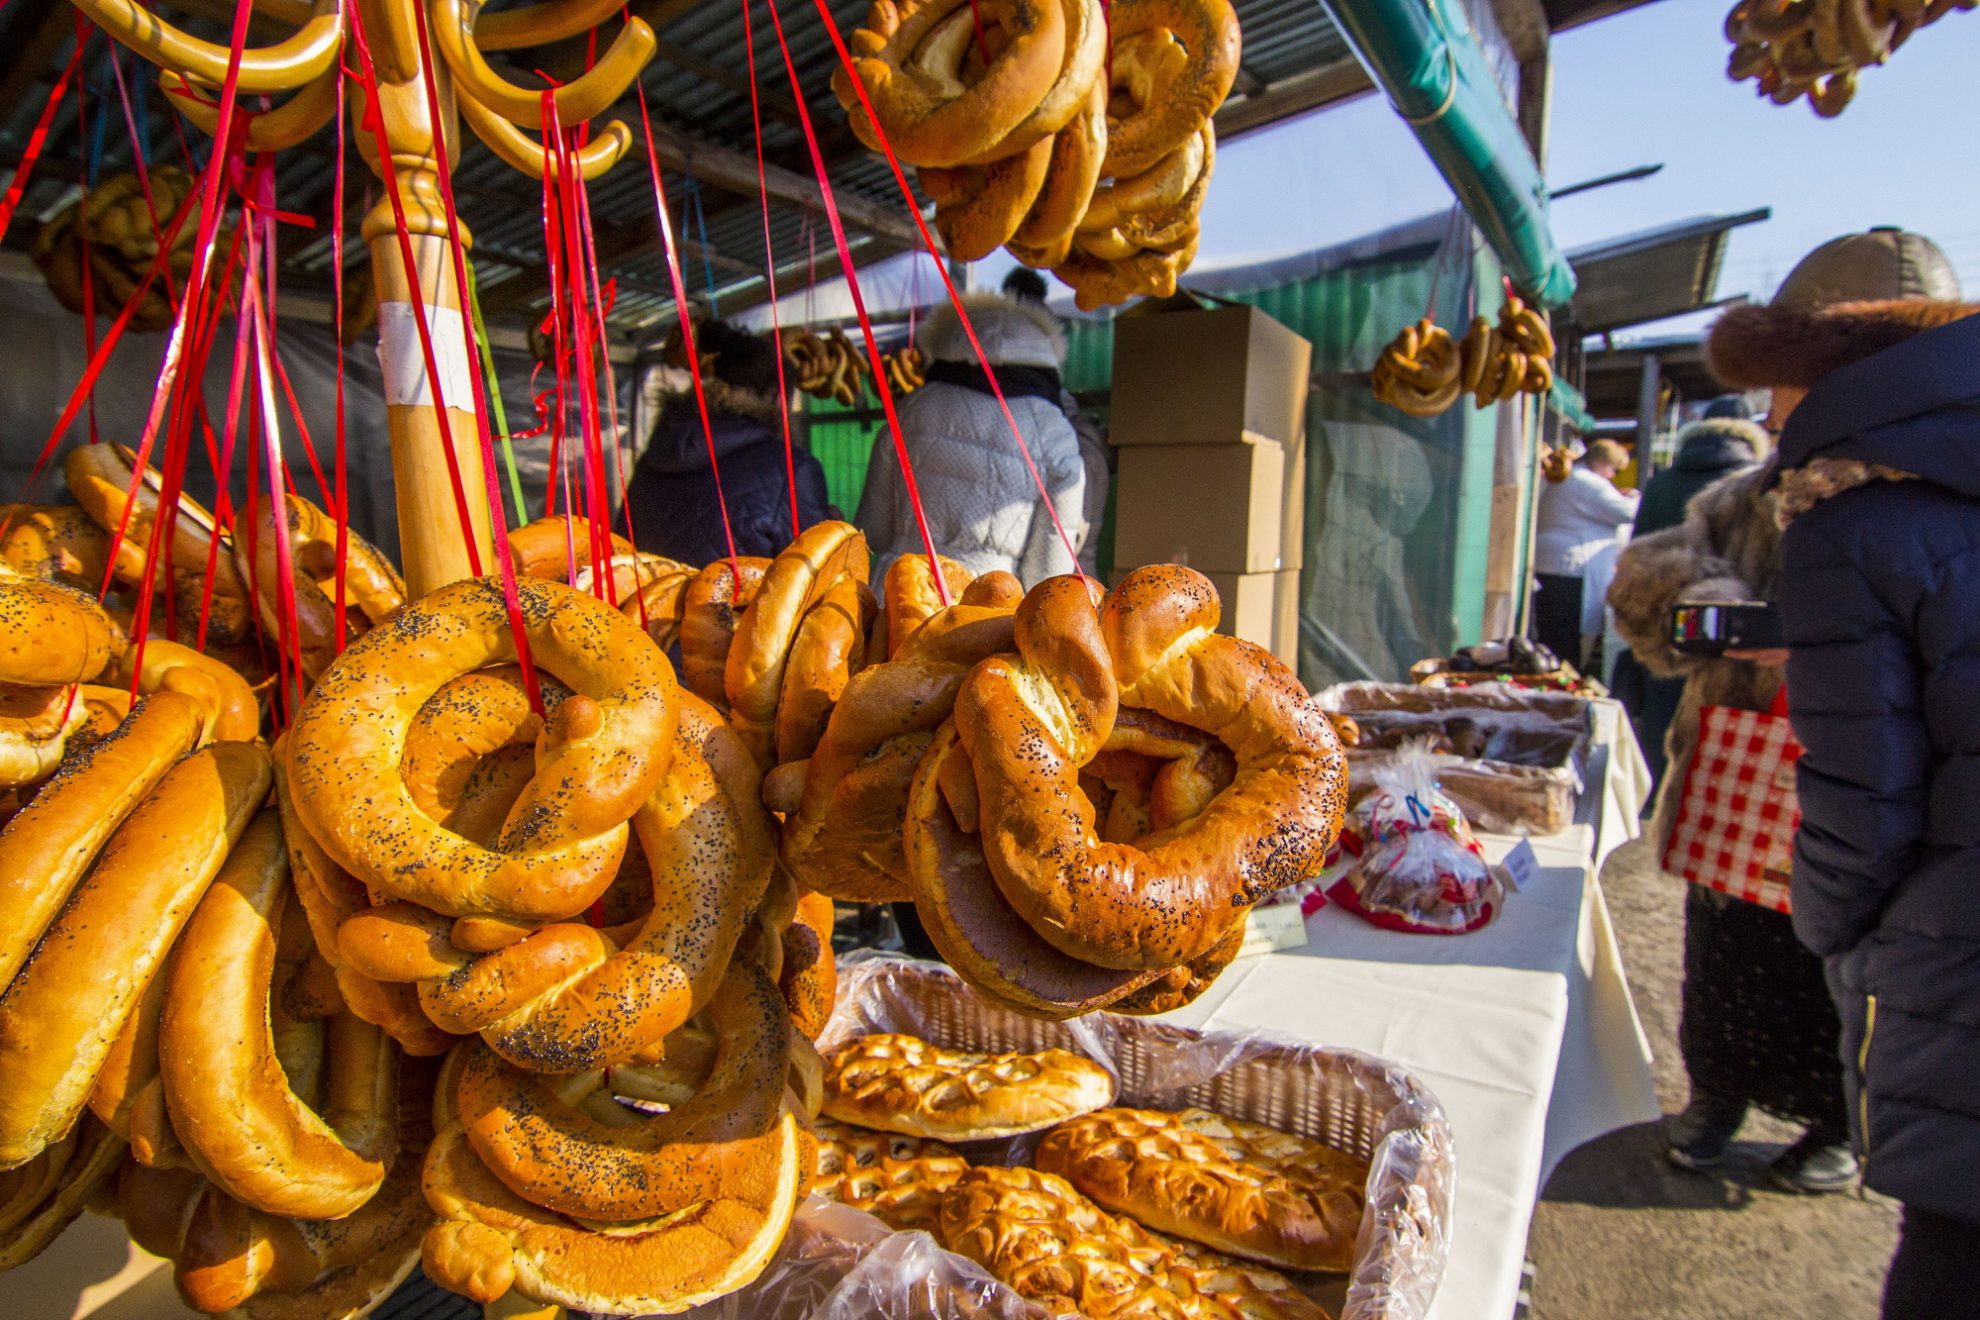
832, 0, 1077, 166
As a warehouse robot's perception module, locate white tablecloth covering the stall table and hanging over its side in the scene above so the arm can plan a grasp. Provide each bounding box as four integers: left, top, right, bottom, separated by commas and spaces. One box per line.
1172, 703, 1659, 1320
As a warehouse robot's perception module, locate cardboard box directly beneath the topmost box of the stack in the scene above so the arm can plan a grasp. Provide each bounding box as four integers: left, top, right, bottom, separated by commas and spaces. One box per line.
1115, 435, 1285, 574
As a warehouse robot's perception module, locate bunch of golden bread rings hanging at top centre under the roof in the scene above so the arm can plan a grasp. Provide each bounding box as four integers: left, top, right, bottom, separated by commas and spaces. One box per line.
832, 0, 1241, 311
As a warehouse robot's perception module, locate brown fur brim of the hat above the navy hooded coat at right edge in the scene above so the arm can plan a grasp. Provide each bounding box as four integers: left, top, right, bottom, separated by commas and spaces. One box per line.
1705, 299, 1980, 390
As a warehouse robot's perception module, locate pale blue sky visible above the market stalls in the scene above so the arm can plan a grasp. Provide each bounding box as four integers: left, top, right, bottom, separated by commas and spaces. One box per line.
748, 0, 1980, 330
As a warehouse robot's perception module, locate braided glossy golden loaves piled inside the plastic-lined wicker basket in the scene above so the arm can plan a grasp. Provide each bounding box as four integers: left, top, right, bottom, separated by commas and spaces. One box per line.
812, 1033, 1368, 1320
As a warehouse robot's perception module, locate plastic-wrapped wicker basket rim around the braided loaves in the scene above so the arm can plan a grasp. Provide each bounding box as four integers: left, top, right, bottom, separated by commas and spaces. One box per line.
818, 952, 1457, 1320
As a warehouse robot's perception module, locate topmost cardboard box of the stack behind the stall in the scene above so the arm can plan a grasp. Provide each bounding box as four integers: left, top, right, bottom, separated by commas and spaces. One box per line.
1107, 307, 1313, 447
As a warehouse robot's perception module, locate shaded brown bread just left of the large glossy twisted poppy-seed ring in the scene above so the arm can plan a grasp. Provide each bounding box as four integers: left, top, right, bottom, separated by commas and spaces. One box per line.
782, 597, 1012, 902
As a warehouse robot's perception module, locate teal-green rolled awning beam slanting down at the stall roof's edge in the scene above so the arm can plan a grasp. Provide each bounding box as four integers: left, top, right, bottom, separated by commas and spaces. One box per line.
1321, 0, 1574, 309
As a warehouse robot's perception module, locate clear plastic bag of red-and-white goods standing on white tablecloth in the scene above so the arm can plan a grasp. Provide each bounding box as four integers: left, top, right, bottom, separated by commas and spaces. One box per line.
1327, 742, 1505, 934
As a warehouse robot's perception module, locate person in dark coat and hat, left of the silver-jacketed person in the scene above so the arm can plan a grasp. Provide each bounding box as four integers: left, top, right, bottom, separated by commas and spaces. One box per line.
626, 321, 830, 566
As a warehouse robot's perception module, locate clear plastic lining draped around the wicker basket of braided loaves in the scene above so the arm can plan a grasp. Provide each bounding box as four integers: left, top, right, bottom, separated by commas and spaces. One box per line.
748, 950, 1457, 1320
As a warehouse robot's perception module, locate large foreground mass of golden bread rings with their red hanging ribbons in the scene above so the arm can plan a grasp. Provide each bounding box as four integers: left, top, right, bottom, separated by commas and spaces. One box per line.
0, 0, 1346, 1320
